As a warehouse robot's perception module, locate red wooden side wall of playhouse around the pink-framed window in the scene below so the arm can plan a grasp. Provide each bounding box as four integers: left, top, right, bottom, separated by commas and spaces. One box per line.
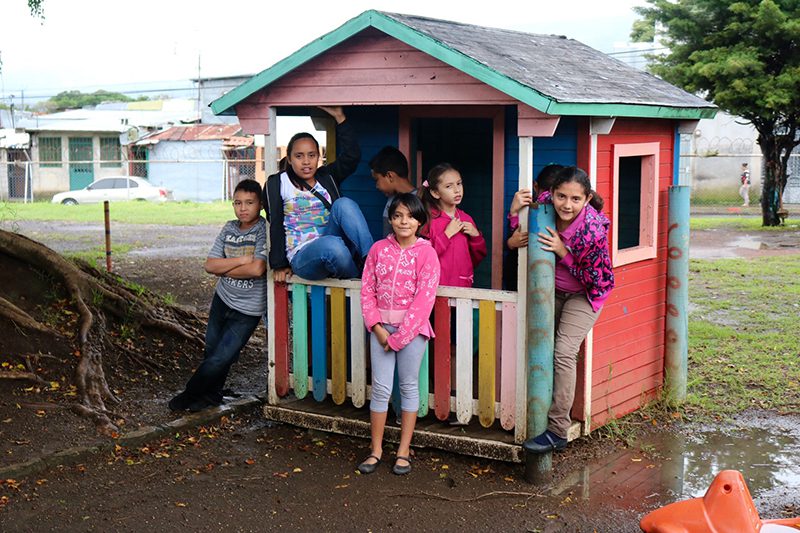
578, 119, 674, 427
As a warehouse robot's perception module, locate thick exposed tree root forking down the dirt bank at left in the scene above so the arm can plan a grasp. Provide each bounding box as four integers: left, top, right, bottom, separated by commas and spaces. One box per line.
0, 230, 204, 435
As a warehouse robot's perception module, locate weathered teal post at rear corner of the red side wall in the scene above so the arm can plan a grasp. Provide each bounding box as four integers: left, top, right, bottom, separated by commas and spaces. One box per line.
664, 185, 690, 403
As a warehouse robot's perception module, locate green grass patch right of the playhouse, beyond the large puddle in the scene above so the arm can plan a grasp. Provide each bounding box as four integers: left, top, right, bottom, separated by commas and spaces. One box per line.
685, 255, 800, 417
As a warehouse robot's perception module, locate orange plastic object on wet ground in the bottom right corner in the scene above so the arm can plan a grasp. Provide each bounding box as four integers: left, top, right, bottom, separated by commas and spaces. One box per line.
639, 470, 800, 533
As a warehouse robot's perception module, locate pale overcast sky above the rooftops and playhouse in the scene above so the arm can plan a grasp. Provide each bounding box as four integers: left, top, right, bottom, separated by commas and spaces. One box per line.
0, 0, 644, 103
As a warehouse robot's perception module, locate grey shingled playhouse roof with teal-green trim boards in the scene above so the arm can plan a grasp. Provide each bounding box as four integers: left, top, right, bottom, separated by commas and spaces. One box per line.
211, 10, 716, 119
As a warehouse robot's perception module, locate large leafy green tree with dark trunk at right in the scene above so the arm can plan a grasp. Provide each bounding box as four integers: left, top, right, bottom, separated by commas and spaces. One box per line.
632, 0, 800, 226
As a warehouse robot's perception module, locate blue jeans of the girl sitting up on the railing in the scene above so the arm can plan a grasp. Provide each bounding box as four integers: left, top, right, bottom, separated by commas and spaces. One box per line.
291, 198, 372, 279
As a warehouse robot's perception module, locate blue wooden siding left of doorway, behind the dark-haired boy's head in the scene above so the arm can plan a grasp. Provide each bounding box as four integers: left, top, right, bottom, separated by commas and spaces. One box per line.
342, 106, 399, 240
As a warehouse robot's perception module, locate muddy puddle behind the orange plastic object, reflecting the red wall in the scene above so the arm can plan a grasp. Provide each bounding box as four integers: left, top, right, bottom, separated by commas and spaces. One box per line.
551, 415, 800, 519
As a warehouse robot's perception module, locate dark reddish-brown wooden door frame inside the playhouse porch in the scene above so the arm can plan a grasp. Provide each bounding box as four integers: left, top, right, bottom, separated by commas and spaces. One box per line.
397, 105, 505, 289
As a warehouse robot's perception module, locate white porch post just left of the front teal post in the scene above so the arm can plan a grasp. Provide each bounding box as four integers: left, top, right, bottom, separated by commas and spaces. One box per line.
514, 137, 533, 443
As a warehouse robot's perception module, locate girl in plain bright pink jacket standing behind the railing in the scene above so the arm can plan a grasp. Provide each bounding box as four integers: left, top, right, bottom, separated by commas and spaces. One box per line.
420, 163, 486, 287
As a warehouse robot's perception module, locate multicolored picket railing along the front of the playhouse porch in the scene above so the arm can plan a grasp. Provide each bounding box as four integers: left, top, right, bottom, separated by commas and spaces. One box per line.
268, 277, 525, 440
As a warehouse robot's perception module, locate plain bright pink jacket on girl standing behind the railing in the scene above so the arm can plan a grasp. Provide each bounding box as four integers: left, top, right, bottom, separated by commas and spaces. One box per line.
428, 209, 486, 287
